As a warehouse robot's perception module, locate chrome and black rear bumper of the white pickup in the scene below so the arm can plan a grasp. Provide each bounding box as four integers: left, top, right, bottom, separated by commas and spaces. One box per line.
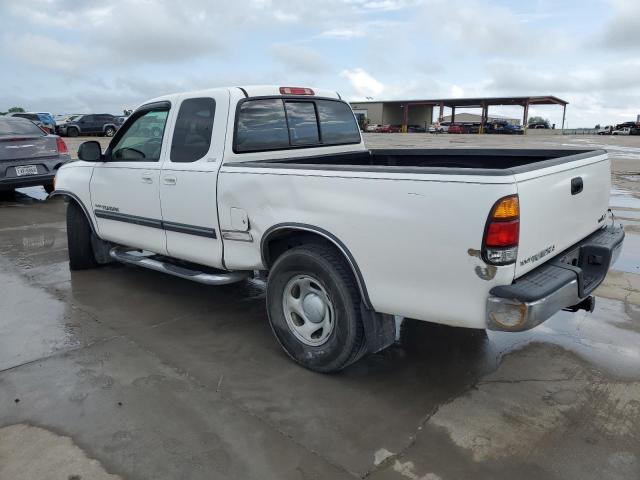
487, 225, 624, 332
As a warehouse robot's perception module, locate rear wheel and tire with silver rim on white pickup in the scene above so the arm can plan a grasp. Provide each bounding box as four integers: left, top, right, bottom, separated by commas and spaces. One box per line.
267, 244, 366, 373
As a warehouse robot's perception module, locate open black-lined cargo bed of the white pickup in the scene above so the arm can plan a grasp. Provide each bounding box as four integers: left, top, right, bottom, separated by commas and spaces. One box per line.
241, 149, 605, 175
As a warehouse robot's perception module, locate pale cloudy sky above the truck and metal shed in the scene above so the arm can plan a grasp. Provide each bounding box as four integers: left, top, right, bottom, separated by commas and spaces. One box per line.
0, 0, 640, 127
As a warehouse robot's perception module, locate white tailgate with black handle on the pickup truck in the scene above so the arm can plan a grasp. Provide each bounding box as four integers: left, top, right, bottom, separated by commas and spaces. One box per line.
514, 151, 611, 278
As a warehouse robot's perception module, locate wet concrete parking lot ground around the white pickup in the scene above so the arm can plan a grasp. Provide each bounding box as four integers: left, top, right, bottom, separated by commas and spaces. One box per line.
0, 134, 640, 480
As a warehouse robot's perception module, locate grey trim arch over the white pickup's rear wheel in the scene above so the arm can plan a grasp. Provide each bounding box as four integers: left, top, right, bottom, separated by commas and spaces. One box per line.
260, 223, 373, 309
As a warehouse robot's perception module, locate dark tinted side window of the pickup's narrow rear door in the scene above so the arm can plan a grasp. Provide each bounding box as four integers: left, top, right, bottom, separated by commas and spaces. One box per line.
171, 98, 216, 163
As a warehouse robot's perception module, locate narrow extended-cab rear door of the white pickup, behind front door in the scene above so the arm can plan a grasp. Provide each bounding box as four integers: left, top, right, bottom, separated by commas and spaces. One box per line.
160, 90, 229, 268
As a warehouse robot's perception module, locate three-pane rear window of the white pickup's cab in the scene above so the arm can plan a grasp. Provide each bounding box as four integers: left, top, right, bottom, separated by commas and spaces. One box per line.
233, 97, 361, 153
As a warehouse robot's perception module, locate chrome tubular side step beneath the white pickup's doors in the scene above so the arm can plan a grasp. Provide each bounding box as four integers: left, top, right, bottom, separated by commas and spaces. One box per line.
109, 247, 252, 285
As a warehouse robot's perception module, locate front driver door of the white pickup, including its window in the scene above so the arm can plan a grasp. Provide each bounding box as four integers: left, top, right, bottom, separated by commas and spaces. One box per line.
91, 102, 171, 255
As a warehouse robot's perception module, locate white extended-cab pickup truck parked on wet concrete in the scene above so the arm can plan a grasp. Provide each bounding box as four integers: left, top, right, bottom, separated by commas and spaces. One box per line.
52, 87, 624, 372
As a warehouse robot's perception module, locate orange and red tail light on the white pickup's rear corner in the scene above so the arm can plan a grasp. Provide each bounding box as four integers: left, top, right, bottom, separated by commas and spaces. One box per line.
482, 195, 520, 265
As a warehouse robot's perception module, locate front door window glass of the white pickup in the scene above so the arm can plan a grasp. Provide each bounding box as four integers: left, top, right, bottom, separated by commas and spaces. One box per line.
111, 110, 169, 162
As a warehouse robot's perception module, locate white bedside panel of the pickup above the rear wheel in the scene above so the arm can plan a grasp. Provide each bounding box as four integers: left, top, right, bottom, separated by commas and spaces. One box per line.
218, 164, 515, 328
